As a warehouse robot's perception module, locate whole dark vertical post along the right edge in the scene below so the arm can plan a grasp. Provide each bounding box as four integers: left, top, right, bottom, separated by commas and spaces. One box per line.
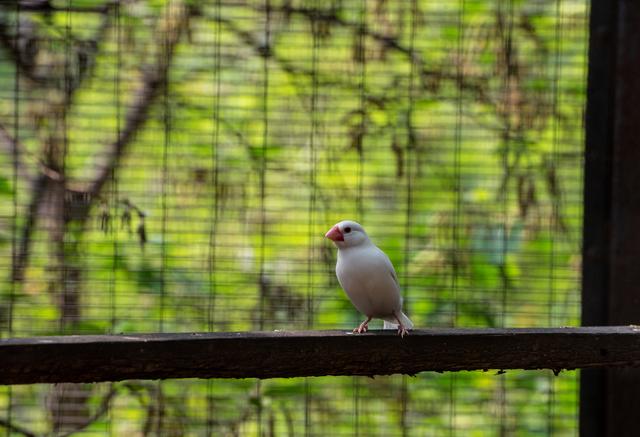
580, 0, 640, 437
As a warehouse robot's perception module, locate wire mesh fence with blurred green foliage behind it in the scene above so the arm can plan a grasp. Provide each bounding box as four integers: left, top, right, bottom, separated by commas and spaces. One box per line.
0, 0, 588, 436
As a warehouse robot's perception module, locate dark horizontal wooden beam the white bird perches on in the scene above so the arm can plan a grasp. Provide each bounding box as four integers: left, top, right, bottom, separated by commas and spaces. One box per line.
0, 326, 640, 384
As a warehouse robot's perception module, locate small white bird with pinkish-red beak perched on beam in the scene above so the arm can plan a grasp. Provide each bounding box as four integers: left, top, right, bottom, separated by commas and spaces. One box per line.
325, 220, 413, 337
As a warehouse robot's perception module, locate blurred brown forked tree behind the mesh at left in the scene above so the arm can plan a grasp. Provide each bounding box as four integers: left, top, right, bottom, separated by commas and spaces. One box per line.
0, 0, 190, 435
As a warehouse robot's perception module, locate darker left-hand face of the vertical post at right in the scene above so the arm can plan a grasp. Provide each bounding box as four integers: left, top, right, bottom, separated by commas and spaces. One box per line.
579, 0, 618, 437
